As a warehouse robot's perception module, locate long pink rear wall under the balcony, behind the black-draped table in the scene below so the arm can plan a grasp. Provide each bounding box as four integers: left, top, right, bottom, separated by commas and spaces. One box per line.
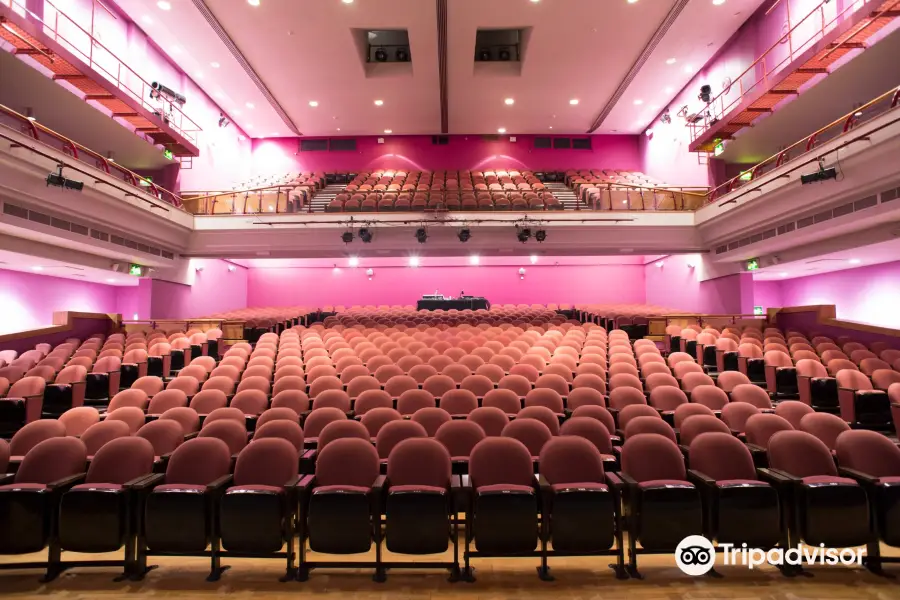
247, 265, 644, 307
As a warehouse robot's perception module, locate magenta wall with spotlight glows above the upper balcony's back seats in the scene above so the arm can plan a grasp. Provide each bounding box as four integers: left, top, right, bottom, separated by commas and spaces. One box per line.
246, 135, 641, 175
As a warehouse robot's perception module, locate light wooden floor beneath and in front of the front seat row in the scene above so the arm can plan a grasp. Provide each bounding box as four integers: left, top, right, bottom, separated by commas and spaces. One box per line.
0, 549, 900, 600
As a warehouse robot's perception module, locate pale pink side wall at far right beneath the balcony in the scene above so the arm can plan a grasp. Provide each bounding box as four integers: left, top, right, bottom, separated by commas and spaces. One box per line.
780, 261, 900, 328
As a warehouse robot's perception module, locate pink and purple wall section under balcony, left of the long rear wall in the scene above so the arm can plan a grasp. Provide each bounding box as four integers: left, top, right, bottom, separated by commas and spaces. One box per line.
150, 259, 250, 319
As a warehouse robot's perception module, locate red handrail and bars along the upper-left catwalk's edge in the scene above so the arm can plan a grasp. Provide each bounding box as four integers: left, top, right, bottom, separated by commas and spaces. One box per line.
3, 0, 202, 143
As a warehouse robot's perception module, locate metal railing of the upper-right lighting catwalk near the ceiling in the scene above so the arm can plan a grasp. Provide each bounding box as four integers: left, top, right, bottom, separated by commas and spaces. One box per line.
688, 0, 884, 141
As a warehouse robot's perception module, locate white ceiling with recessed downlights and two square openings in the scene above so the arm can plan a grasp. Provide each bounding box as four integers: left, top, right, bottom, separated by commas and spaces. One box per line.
107, 0, 765, 137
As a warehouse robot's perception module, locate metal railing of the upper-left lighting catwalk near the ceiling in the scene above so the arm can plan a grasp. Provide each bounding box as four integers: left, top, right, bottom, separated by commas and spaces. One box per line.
0, 0, 202, 144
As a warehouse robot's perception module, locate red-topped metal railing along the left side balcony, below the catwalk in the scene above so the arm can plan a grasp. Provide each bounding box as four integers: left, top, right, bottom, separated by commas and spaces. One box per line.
0, 104, 182, 208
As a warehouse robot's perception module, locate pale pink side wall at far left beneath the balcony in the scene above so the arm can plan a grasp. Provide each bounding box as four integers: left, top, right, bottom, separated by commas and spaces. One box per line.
0, 269, 121, 334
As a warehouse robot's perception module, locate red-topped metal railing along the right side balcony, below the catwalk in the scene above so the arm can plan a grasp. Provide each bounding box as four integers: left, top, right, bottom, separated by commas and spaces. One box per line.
706, 87, 900, 203
